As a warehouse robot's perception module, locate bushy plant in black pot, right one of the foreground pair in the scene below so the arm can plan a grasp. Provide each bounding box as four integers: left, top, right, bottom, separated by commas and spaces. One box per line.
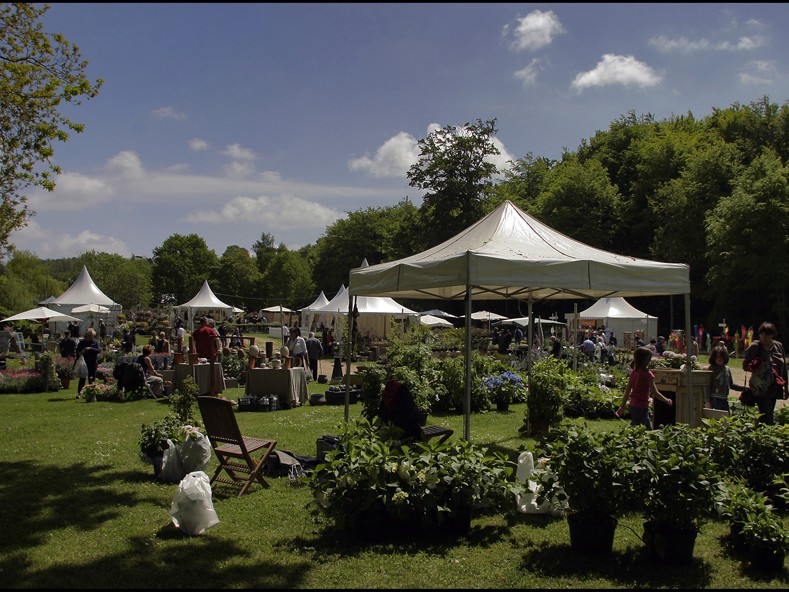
634, 424, 725, 562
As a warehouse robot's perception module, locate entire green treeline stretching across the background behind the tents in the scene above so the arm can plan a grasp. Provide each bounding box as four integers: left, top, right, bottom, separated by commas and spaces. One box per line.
0, 97, 789, 333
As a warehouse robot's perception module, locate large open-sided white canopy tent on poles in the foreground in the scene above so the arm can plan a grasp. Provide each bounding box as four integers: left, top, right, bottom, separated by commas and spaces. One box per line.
346, 201, 692, 440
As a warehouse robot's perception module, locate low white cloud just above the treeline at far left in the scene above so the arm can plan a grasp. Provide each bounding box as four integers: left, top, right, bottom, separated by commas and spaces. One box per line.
11, 220, 132, 259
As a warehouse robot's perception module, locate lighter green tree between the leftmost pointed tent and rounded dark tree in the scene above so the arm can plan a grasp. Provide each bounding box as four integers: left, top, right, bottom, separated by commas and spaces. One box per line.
79, 251, 152, 310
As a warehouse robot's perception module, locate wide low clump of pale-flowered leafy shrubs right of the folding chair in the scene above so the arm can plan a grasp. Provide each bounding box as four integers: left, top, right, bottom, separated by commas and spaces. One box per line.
308, 419, 521, 539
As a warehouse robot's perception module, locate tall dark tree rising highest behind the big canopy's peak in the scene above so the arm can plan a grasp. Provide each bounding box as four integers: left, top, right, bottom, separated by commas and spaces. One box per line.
407, 119, 500, 247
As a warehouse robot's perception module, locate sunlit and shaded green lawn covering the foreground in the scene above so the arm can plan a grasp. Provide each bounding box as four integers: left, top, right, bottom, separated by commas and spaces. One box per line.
0, 360, 787, 589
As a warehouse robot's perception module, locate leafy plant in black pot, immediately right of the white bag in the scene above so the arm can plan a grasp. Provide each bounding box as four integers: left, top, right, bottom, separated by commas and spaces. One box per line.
537, 426, 641, 554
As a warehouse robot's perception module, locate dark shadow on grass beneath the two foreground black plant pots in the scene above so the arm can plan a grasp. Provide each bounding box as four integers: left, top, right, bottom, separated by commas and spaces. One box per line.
521, 543, 712, 588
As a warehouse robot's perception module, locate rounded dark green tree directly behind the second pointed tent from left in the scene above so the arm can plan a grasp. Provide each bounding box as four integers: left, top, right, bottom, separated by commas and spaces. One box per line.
151, 234, 219, 304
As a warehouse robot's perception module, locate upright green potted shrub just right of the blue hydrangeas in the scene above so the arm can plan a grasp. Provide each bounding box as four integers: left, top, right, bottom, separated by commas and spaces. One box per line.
526, 357, 567, 435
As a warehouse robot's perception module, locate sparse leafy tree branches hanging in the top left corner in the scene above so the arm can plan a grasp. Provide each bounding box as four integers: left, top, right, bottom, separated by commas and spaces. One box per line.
0, 3, 103, 252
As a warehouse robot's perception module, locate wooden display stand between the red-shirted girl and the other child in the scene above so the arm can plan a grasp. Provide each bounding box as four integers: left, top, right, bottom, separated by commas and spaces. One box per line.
652, 368, 712, 427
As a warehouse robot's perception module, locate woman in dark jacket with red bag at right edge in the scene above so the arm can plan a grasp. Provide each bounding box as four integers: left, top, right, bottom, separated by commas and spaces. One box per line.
742, 322, 789, 425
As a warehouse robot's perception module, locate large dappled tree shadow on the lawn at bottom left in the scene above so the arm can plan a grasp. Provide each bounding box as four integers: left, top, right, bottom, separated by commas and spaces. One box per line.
0, 460, 310, 589
